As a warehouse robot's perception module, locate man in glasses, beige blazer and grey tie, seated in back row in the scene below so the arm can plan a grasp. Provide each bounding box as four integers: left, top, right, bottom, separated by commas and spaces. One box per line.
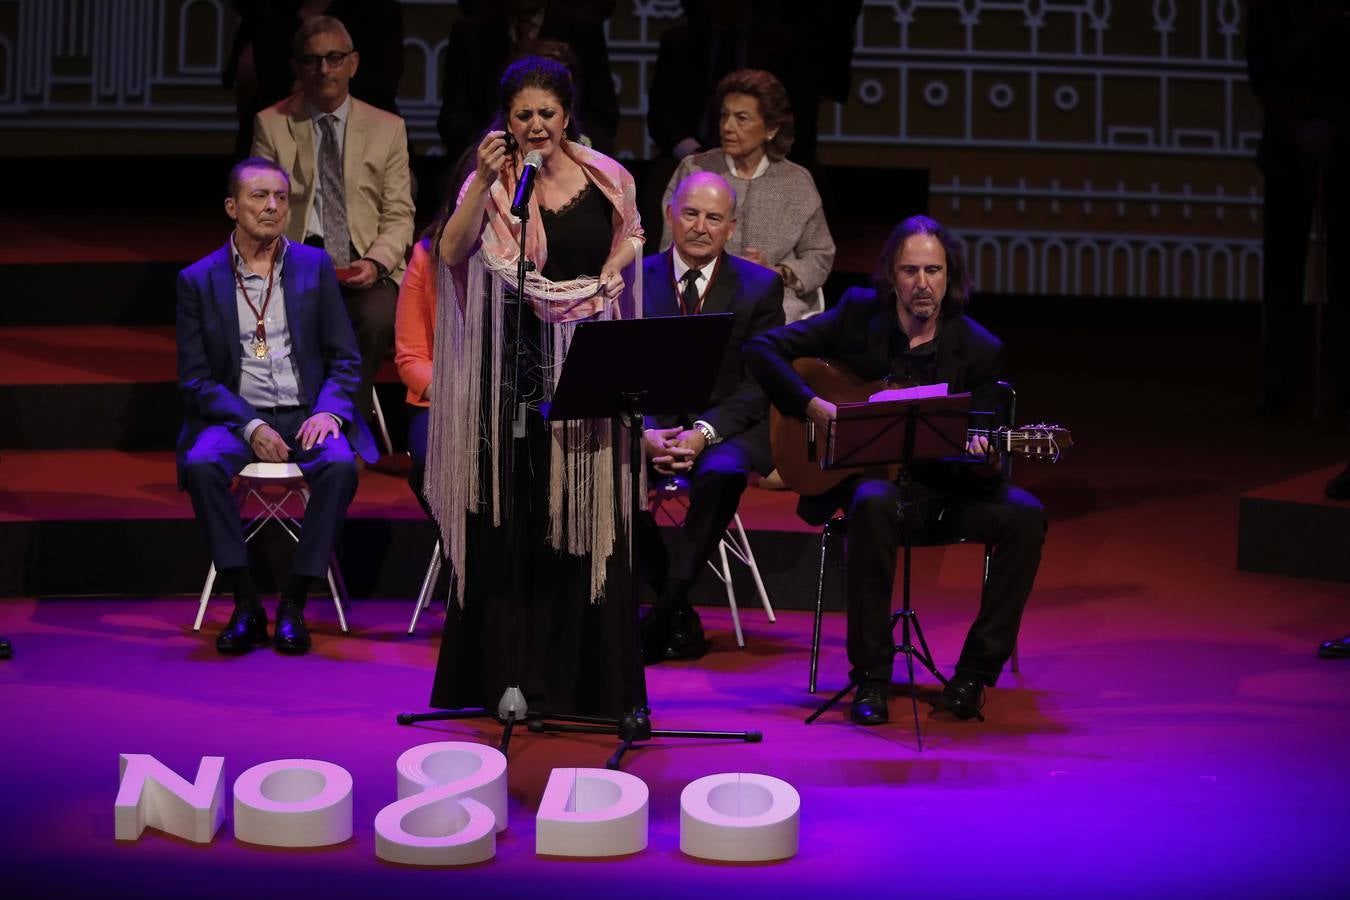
252, 16, 413, 437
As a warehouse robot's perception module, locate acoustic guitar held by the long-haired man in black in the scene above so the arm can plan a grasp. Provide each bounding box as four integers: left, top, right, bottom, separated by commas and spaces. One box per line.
770, 358, 1073, 497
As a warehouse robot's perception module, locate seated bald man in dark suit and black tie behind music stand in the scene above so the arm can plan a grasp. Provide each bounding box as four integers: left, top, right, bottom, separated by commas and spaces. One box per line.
641, 171, 783, 663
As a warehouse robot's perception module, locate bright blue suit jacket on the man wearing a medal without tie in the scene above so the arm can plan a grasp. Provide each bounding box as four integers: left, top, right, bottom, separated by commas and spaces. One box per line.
177, 242, 379, 480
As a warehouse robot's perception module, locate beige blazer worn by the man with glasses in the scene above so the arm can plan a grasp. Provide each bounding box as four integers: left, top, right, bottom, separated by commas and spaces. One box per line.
252, 93, 413, 281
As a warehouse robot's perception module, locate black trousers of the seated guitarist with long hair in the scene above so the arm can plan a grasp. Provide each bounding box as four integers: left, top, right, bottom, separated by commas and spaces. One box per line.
836, 478, 1046, 685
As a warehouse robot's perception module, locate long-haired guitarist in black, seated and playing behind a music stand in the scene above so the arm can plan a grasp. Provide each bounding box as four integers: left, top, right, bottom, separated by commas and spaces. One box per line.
744, 216, 1045, 725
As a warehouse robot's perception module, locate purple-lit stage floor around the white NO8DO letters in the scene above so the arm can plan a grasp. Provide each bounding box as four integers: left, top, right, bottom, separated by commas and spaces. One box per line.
0, 577, 1350, 897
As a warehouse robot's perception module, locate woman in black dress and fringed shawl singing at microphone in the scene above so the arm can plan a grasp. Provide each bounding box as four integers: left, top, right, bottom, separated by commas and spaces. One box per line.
425, 57, 645, 716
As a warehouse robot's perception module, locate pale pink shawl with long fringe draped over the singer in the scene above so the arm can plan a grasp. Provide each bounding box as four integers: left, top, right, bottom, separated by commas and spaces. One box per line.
424, 142, 643, 603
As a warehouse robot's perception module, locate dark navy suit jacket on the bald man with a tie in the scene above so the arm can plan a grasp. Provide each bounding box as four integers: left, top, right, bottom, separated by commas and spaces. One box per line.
643, 250, 783, 474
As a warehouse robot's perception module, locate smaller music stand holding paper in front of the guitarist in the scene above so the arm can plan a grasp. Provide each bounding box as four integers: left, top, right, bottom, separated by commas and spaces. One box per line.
806, 394, 984, 752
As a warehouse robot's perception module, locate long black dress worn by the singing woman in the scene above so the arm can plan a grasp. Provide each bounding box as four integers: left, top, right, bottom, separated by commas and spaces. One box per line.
431, 184, 647, 716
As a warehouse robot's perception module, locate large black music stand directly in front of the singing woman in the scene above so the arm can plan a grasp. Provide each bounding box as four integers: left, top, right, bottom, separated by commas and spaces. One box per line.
398, 313, 763, 769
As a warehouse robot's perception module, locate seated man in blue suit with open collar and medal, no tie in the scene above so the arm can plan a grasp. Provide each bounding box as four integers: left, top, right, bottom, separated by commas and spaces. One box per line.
177, 157, 378, 653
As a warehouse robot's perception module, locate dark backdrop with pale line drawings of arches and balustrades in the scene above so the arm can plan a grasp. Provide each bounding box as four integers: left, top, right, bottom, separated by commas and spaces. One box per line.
0, 0, 1261, 300
